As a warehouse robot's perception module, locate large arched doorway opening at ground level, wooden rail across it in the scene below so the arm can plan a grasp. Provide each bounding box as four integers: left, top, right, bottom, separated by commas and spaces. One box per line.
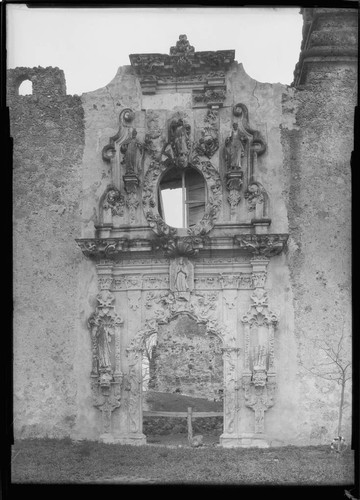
142, 311, 224, 446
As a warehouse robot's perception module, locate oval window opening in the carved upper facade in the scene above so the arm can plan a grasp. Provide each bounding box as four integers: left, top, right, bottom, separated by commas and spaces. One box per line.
158, 167, 207, 228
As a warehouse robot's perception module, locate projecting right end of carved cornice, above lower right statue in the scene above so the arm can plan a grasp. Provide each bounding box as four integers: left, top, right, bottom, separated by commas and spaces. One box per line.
234, 234, 289, 257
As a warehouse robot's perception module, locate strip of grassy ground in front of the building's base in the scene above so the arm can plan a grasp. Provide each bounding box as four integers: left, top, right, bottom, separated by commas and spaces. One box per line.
12, 439, 354, 486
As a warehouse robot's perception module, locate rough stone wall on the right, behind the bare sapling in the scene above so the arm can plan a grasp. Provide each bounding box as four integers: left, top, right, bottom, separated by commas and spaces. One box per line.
282, 9, 357, 443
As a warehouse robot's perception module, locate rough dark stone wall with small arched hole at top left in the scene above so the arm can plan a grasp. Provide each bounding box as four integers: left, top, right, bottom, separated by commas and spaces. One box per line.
8, 68, 84, 438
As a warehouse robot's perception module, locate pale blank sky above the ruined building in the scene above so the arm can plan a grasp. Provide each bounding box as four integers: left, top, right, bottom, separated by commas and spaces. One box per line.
7, 4, 303, 95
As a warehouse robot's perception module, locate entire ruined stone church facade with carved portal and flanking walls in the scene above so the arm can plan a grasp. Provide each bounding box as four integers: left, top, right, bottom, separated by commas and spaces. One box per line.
8, 8, 357, 446
